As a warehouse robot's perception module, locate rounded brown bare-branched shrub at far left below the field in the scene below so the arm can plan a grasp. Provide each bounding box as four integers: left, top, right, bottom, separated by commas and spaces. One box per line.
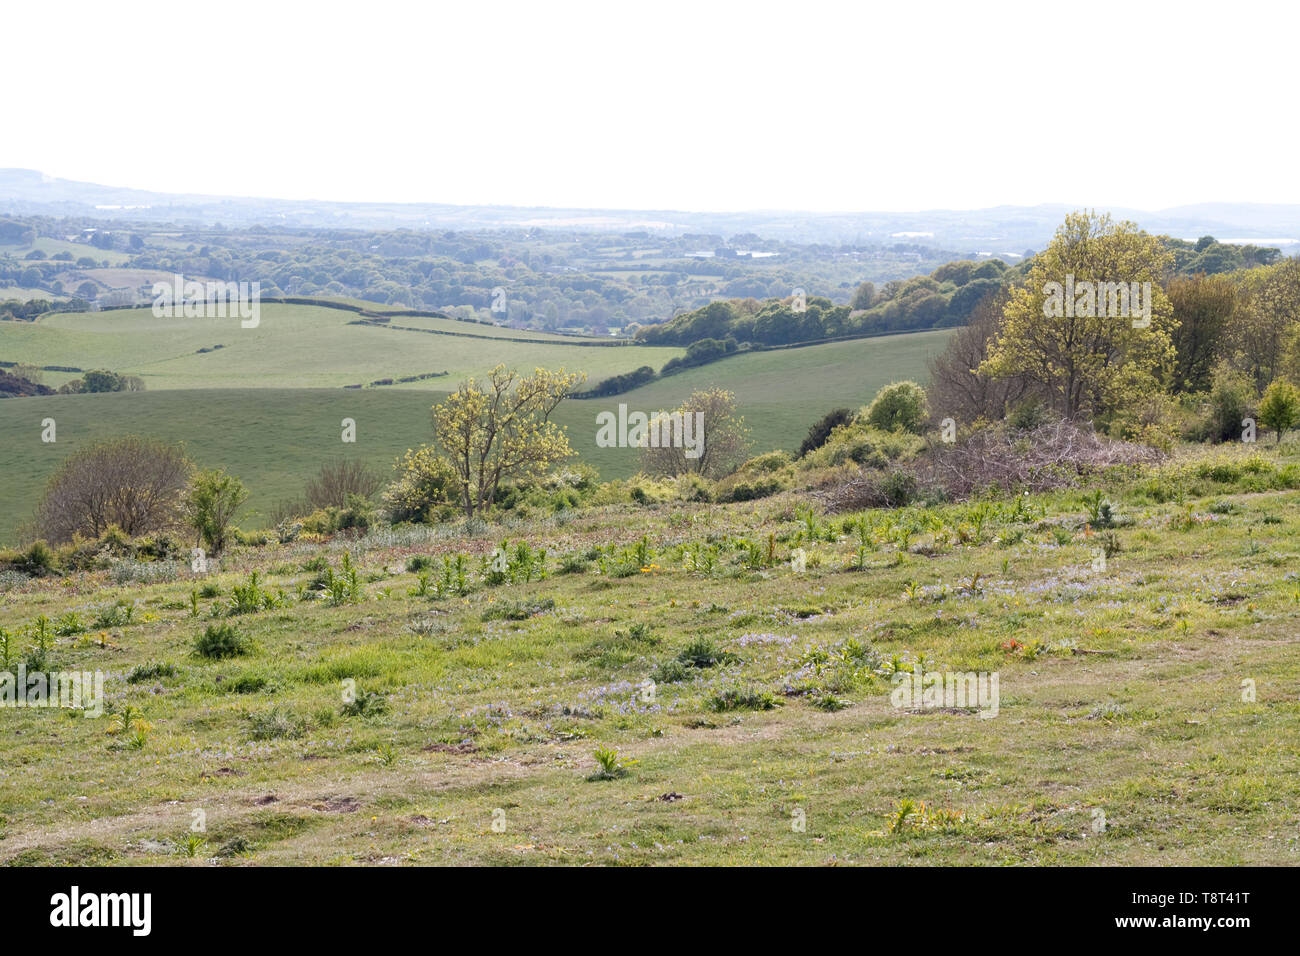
36, 436, 191, 544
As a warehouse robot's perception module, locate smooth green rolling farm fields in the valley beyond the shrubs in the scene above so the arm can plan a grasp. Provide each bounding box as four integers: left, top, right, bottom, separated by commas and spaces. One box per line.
0, 306, 949, 542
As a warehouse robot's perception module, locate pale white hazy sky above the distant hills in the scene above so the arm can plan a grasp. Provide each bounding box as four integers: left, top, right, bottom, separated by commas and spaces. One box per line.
0, 0, 1300, 211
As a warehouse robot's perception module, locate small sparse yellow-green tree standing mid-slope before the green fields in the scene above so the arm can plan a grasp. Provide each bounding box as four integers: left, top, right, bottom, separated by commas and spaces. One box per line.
433, 365, 586, 518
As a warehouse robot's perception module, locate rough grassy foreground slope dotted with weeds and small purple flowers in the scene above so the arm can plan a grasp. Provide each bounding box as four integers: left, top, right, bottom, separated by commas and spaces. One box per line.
0, 444, 1300, 866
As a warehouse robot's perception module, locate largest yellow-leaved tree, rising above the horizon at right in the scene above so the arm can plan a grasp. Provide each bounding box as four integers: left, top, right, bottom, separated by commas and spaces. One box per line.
980, 212, 1175, 419
